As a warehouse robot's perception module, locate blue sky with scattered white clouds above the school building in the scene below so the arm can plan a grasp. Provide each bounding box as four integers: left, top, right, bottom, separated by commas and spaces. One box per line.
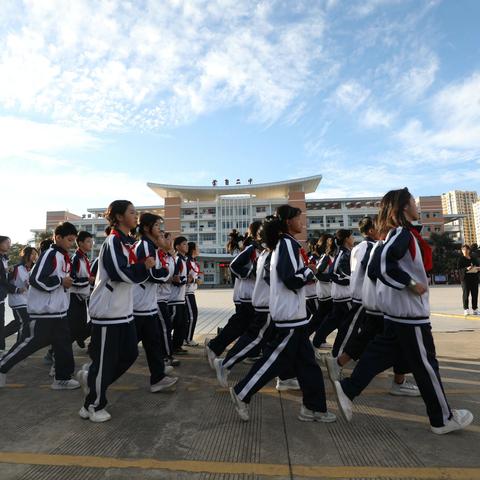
0, 0, 480, 241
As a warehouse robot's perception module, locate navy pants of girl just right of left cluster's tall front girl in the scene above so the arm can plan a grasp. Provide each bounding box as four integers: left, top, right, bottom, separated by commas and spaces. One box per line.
134, 315, 165, 385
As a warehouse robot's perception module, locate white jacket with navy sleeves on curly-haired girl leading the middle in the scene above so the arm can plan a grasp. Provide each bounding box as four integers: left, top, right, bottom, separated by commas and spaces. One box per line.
270, 234, 313, 328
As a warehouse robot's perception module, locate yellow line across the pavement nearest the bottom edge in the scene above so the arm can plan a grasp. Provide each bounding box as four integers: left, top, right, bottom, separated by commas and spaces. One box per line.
0, 452, 480, 480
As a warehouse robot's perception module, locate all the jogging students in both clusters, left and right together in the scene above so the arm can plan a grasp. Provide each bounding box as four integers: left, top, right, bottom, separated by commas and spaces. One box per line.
0, 188, 473, 434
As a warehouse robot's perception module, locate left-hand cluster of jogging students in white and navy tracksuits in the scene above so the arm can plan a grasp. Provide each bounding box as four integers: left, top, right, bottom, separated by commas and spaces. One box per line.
0, 200, 200, 422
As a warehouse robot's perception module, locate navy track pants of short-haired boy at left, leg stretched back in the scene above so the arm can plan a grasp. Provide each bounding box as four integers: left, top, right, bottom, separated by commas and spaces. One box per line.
0, 317, 74, 380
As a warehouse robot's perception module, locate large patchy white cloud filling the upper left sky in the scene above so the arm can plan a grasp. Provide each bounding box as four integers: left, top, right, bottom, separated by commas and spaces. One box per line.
0, 0, 329, 130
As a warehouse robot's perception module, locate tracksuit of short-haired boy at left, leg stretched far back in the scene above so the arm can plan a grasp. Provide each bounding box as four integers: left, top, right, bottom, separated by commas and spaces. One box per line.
0, 244, 74, 380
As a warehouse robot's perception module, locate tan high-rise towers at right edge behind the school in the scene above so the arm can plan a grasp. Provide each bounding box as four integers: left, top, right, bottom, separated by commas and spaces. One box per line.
442, 190, 478, 244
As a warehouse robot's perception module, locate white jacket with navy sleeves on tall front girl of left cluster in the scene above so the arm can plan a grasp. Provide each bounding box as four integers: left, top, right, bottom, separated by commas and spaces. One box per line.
90, 231, 148, 325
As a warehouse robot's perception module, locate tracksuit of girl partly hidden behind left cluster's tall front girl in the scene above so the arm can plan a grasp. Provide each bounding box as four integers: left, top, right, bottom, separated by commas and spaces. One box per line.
133, 237, 169, 385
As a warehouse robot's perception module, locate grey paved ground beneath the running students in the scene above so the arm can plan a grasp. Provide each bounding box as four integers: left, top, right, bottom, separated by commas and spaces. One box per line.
0, 287, 480, 480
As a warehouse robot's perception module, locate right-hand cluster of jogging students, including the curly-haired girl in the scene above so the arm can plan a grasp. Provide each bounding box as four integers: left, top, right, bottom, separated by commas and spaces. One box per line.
205, 188, 473, 434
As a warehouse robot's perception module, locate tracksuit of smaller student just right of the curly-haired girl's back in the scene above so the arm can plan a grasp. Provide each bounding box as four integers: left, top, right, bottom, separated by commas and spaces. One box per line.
309, 253, 335, 348
